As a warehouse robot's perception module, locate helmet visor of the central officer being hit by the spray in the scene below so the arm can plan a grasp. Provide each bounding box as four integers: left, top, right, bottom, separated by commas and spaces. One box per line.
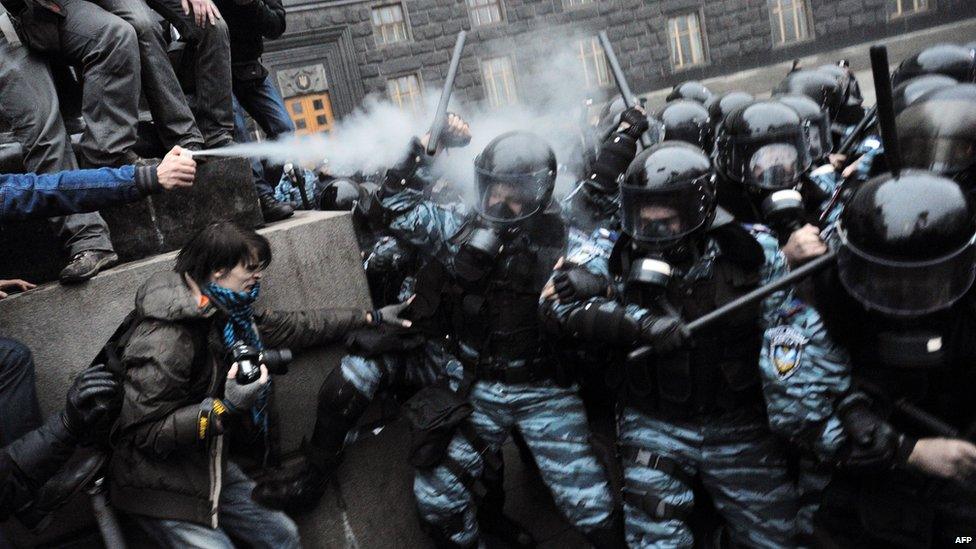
476, 169, 555, 224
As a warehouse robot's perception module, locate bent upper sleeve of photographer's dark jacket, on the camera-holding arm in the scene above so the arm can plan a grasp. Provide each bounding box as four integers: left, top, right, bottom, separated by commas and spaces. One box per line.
116, 320, 202, 458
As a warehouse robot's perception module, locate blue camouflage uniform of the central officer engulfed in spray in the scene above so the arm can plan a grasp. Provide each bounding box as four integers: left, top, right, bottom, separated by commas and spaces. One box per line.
383, 189, 613, 546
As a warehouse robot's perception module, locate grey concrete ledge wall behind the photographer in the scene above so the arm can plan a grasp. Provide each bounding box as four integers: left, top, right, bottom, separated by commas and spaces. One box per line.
0, 212, 424, 547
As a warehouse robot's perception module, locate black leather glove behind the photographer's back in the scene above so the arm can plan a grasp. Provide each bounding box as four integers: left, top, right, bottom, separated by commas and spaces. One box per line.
61, 364, 122, 441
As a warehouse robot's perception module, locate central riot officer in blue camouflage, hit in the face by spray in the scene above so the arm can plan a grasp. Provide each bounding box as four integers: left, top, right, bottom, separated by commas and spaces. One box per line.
383, 132, 619, 547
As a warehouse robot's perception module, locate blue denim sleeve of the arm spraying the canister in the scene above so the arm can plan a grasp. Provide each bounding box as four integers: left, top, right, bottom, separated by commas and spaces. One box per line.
0, 166, 160, 222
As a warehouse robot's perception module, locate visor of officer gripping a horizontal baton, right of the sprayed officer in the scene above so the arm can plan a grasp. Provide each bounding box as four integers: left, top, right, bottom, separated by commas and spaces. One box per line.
620, 178, 714, 244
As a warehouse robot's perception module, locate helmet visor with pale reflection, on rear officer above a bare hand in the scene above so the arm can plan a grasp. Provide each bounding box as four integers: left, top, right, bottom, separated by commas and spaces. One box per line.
723, 131, 810, 191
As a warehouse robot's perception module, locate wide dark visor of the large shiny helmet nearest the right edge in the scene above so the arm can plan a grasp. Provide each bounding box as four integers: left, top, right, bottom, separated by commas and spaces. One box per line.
837, 224, 976, 317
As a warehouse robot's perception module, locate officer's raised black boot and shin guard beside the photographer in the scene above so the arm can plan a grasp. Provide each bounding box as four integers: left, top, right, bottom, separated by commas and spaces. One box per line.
251, 368, 370, 514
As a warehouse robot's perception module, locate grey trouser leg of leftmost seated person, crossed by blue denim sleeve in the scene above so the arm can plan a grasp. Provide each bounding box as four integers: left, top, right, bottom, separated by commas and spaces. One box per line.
0, 35, 112, 256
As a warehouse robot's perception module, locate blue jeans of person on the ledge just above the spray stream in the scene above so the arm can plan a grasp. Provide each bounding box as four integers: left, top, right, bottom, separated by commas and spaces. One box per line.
234, 76, 295, 196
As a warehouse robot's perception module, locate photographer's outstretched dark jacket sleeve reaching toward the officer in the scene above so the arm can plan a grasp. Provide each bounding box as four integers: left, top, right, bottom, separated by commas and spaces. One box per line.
256, 309, 366, 349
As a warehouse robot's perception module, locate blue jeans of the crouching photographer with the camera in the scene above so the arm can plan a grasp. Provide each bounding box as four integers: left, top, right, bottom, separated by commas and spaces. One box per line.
135, 462, 301, 549
